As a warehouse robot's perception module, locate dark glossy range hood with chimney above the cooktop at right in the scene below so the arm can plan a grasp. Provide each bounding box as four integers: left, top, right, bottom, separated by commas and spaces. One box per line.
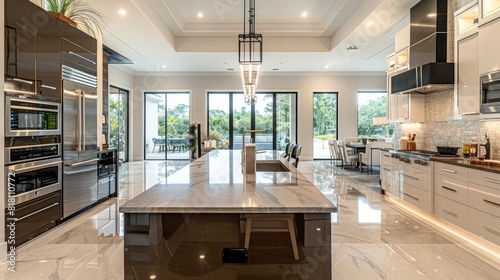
391, 0, 454, 94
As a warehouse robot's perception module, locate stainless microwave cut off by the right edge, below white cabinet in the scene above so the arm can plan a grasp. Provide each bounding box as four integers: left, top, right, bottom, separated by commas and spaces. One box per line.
480, 71, 500, 113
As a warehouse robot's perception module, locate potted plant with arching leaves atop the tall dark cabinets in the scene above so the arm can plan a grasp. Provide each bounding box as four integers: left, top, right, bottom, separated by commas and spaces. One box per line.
45, 0, 104, 38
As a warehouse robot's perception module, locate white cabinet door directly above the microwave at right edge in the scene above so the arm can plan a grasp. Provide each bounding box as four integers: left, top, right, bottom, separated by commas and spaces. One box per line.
479, 15, 500, 74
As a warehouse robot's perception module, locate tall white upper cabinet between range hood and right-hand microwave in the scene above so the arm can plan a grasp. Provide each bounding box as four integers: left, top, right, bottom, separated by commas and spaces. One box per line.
455, 2, 480, 115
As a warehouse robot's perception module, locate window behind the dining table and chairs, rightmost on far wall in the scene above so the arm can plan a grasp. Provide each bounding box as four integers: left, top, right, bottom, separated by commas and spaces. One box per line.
358, 91, 387, 137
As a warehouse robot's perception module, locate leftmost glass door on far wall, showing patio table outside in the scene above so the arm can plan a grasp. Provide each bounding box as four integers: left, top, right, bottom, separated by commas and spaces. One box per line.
144, 92, 190, 160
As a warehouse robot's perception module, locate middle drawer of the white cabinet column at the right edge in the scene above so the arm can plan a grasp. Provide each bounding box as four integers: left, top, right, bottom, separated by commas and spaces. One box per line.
469, 183, 500, 220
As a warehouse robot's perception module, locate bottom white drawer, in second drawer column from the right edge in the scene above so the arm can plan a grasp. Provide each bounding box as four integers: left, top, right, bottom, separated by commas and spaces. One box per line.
434, 195, 469, 230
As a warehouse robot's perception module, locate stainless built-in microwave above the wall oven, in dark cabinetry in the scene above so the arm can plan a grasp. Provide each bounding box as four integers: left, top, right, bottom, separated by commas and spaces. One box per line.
5, 96, 61, 137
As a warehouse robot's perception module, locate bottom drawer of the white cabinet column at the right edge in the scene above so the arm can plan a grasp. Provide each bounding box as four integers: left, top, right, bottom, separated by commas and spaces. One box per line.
469, 208, 500, 245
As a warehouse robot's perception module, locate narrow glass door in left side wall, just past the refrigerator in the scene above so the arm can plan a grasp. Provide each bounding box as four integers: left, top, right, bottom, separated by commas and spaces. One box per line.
108, 86, 128, 162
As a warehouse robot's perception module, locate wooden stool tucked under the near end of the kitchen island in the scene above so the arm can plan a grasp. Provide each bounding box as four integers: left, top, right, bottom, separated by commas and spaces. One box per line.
245, 214, 299, 260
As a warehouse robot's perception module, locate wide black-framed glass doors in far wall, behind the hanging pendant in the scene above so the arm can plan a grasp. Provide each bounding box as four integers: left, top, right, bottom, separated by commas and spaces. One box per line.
208, 92, 297, 150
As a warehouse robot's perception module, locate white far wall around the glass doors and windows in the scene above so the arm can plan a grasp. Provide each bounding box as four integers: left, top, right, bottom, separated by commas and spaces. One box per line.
131, 75, 386, 160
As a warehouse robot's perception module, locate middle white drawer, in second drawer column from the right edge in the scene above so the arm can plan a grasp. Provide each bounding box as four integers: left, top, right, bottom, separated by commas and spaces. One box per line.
434, 173, 468, 204
